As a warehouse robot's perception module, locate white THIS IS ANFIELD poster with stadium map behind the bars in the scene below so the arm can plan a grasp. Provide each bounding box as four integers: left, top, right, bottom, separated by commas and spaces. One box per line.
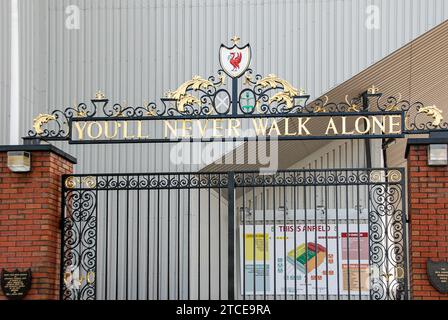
240, 223, 369, 295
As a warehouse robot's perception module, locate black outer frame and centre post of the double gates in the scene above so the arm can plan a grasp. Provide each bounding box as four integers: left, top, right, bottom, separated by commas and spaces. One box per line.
60, 168, 409, 300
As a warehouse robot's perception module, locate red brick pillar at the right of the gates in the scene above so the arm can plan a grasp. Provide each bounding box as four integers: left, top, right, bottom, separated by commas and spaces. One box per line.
406, 139, 448, 300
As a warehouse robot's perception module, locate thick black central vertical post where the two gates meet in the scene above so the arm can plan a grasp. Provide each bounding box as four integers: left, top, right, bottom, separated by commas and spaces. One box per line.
227, 172, 235, 300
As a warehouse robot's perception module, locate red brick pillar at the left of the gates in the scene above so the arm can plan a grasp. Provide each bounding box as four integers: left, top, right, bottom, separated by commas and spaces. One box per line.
0, 145, 76, 300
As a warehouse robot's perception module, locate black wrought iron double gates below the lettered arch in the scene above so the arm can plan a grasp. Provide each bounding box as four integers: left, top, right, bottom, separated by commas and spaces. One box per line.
61, 168, 407, 300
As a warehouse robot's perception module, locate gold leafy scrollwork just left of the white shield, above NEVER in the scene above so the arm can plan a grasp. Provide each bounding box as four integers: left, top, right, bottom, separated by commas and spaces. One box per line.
166, 76, 214, 112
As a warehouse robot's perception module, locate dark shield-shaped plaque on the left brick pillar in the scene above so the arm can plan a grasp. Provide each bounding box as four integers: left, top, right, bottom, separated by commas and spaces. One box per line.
1, 269, 31, 299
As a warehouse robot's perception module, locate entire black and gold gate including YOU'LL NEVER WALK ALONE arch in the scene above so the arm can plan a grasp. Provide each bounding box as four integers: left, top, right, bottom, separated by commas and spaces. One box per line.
25, 37, 434, 299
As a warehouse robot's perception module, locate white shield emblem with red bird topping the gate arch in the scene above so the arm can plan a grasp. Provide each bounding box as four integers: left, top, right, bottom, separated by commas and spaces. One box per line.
219, 44, 252, 78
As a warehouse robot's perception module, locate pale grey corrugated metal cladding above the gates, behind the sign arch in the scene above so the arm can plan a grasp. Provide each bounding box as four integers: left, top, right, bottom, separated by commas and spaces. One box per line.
0, 0, 448, 172
